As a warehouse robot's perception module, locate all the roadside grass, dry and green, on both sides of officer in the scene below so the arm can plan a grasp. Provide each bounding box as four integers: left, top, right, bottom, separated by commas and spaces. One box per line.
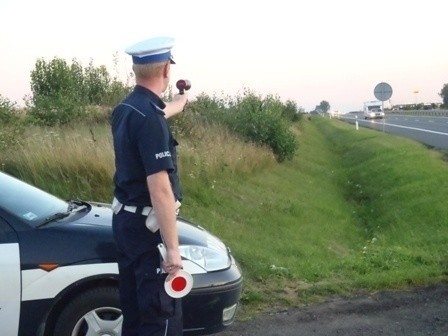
1, 118, 448, 318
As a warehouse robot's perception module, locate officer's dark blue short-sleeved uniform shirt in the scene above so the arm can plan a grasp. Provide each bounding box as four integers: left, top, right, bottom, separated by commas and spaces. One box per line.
112, 85, 182, 206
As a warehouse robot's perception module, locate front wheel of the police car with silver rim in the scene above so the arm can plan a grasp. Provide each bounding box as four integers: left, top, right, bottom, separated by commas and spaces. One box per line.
54, 287, 123, 336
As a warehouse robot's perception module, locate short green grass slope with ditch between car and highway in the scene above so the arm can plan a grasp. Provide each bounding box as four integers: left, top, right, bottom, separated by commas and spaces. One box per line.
185, 119, 448, 316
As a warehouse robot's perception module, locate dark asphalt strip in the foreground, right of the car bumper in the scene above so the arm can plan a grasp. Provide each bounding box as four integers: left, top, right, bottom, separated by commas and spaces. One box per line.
219, 284, 448, 336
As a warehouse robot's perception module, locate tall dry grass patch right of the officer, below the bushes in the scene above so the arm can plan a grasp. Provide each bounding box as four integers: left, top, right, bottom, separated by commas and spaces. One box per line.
179, 119, 276, 207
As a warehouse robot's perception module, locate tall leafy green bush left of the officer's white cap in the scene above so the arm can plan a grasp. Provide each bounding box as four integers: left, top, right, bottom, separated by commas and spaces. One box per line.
28, 58, 130, 126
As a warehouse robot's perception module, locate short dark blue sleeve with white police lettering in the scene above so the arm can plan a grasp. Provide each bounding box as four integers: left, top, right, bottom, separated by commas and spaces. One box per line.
138, 113, 174, 176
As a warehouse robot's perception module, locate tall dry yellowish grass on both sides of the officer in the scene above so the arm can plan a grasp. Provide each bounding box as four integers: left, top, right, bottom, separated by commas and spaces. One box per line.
0, 123, 275, 202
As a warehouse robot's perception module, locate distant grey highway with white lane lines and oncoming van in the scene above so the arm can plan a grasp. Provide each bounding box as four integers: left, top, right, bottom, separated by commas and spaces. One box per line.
340, 113, 448, 149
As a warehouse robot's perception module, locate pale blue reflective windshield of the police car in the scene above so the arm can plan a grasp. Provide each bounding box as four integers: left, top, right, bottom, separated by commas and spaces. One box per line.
0, 172, 69, 226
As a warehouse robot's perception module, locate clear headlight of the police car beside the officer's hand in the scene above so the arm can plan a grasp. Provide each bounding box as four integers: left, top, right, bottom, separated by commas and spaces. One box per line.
180, 237, 231, 272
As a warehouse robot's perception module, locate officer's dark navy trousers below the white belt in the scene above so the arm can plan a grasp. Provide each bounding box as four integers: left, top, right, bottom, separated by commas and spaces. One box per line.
113, 211, 182, 336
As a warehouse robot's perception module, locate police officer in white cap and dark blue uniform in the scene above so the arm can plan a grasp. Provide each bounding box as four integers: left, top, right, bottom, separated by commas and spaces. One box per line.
112, 37, 187, 336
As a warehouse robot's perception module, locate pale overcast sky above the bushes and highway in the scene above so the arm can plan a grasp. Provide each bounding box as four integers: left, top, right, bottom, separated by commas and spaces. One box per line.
0, 0, 448, 112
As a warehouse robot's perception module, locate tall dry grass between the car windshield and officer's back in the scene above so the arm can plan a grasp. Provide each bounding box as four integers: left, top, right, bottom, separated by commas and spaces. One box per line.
0, 124, 114, 201
